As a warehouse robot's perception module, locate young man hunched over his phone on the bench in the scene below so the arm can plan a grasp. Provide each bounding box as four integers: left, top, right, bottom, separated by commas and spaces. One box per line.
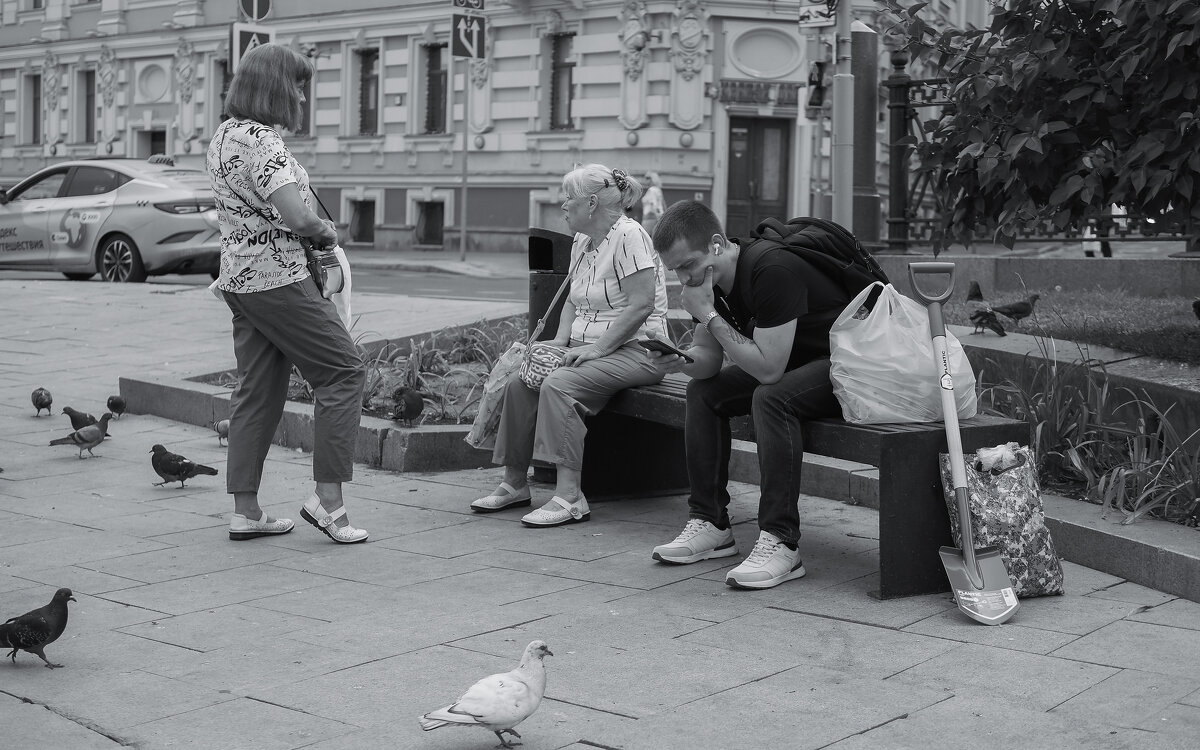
652, 200, 850, 588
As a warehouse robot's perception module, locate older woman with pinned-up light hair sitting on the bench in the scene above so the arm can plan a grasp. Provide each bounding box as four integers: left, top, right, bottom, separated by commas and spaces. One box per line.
470, 164, 670, 527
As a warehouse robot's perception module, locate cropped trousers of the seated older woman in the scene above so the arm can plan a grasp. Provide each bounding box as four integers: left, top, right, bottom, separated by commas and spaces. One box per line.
492, 342, 662, 470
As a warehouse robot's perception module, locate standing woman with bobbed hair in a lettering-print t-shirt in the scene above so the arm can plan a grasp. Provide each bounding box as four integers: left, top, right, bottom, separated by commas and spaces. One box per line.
208, 44, 367, 544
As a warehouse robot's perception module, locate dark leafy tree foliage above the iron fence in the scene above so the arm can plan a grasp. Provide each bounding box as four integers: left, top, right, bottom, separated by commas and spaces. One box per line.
886, 0, 1200, 249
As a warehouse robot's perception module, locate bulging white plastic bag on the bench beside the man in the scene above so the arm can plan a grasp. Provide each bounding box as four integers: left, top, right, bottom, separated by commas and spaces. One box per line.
829, 282, 978, 425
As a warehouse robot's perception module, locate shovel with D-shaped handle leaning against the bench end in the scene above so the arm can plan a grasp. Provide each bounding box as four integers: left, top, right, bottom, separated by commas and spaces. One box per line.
908, 263, 1019, 625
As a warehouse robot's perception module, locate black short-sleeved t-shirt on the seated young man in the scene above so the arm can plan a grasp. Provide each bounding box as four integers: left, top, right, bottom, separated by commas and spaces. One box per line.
714, 245, 850, 371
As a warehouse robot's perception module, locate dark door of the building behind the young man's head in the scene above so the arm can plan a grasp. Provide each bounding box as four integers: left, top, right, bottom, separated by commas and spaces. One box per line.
725, 118, 792, 238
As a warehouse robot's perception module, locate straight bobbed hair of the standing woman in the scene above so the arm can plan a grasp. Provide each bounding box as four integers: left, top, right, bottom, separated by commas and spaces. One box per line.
226, 43, 312, 131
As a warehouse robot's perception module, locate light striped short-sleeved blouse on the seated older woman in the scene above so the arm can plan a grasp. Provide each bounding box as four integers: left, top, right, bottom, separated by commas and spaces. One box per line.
568, 216, 670, 343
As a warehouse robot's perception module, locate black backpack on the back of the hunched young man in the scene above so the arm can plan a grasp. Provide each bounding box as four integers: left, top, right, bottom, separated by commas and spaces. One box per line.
746, 216, 890, 299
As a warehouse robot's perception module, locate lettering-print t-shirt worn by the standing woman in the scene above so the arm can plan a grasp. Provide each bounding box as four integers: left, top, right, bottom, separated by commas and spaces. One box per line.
208, 120, 312, 294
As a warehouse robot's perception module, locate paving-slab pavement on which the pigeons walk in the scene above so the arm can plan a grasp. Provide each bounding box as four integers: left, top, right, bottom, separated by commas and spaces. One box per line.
0, 281, 1200, 750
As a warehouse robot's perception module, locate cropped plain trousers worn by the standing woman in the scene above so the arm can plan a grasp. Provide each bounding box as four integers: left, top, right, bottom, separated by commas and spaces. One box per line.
224, 278, 366, 493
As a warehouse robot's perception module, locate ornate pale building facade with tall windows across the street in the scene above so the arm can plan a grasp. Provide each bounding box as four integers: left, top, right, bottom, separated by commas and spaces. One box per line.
0, 0, 988, 251
